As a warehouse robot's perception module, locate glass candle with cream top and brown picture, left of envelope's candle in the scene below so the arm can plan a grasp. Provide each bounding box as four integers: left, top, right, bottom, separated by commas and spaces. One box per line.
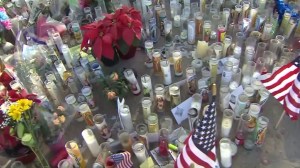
154, 84, 165, 112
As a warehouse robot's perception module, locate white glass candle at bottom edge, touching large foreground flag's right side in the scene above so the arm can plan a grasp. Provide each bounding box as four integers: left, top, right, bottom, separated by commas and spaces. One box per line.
219, 138, 232, 168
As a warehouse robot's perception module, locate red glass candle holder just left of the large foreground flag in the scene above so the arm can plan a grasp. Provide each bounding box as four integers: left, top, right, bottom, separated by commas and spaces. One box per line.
158, 128, 169, 158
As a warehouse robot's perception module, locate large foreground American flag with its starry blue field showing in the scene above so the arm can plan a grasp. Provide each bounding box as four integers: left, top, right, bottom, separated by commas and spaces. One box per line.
175, 101, 219, 168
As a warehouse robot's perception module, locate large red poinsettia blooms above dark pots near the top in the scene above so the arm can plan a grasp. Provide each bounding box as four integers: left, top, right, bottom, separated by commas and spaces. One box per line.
81, 6, 142, 60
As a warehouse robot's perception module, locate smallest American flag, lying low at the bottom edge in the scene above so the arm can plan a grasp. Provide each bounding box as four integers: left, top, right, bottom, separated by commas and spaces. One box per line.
111, 152, 133, 168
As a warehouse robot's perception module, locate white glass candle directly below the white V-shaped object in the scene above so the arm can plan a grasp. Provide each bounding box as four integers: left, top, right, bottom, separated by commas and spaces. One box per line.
120, 105, 134, 132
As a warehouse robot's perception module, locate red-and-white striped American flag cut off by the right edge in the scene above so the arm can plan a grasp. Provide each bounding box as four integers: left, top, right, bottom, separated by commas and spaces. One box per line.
261, 56, 300, 120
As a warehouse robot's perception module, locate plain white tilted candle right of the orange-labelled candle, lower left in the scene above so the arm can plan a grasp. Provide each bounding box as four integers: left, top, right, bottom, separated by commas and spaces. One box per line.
81, 129, 100, 157
